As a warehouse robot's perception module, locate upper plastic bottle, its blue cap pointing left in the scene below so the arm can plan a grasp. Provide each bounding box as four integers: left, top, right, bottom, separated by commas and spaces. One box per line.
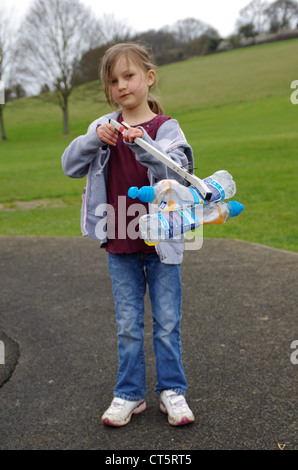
128, 170, 236, 210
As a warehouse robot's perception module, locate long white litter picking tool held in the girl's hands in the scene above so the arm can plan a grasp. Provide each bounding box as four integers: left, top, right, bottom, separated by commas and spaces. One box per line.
109, 119, 212, 201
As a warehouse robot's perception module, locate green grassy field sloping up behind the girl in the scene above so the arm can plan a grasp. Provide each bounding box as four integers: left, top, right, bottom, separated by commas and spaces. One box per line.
0, 39, 298, 252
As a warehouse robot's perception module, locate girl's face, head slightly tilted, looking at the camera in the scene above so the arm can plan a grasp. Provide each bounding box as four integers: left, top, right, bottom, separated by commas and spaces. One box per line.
111, 57, 155, 110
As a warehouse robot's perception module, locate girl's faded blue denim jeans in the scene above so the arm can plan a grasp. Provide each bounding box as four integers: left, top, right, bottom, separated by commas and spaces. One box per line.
108, 253, 187, 401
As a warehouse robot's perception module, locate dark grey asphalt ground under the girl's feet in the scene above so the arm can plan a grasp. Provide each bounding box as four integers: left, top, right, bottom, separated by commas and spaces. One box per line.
0, 237, 298, 453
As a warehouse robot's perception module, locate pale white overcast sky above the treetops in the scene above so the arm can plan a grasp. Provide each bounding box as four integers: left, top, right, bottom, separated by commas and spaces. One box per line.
0, 0, 250, 37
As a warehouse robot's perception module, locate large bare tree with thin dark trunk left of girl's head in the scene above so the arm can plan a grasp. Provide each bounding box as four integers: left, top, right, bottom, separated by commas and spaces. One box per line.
19, 0, 100, 135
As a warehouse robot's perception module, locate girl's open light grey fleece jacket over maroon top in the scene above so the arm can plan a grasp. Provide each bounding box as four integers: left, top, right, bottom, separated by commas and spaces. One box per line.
62, 112, 193, 264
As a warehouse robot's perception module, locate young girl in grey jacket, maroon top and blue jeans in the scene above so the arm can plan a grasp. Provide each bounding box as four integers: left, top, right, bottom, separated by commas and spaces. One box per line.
62, 43, 194, 426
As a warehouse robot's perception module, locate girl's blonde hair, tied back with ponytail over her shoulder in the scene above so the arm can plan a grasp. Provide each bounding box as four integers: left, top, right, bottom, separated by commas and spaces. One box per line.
100, 43, 163, 114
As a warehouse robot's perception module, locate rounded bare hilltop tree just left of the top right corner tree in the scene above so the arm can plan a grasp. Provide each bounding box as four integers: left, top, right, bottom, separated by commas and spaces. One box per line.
236, 0, 269, 36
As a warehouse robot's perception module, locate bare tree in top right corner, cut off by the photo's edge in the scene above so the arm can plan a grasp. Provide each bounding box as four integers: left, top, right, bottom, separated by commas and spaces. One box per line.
265, 0, 298, 33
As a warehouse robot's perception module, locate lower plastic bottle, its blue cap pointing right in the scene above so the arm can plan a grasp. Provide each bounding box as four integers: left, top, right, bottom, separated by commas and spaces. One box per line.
139, 201, 244, 244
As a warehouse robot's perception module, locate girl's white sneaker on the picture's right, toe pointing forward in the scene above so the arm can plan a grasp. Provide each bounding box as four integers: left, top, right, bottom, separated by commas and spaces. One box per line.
160, 390, 195, 426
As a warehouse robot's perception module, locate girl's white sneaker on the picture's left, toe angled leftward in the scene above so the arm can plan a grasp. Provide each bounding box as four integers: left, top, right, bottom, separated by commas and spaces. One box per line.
101, 397, 146, 426
